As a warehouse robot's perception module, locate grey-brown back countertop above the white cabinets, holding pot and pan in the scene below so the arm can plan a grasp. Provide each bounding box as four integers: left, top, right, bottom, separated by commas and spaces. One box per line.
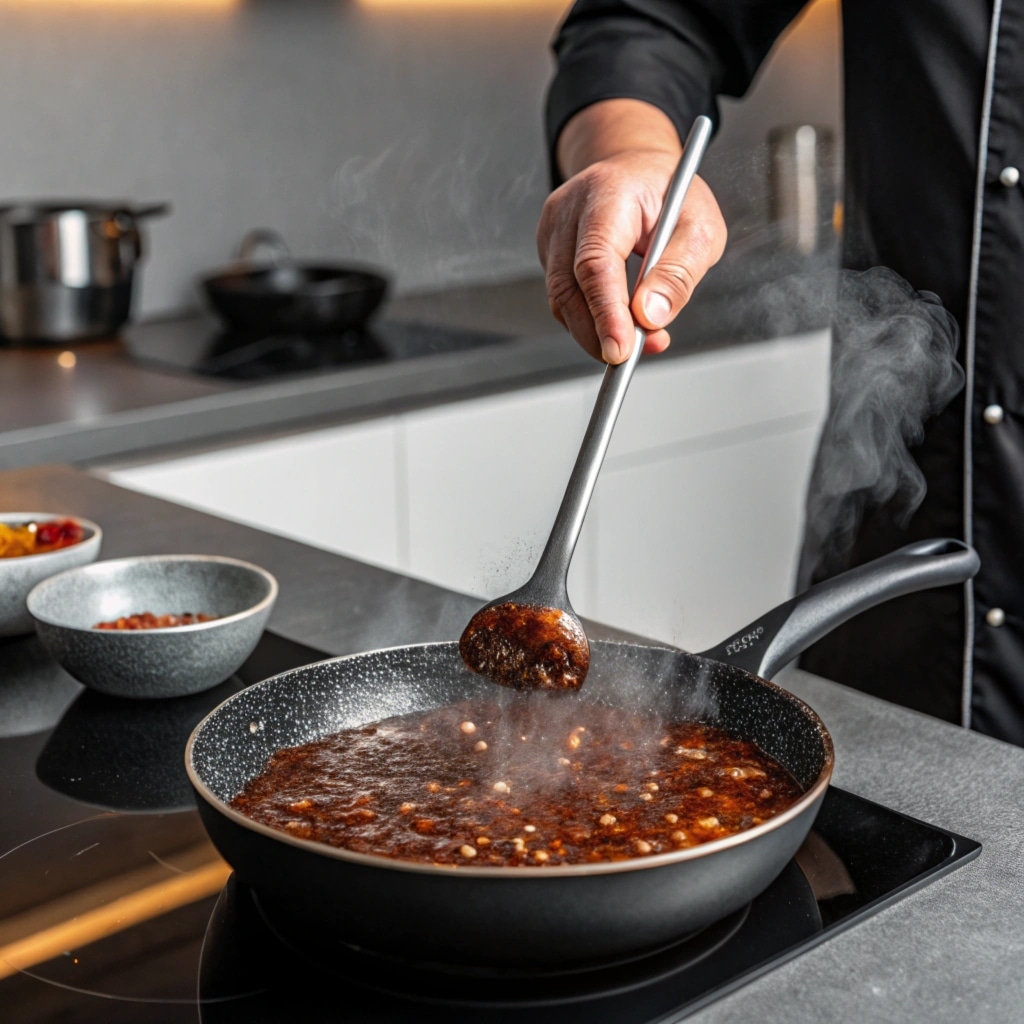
0, 254, 820, 469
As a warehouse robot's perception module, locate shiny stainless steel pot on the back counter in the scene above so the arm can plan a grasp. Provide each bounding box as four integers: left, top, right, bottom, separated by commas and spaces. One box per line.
0, 201, 169, 342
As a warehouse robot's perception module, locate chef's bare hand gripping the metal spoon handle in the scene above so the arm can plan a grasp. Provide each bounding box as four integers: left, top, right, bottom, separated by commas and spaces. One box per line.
538, 109, 727, 362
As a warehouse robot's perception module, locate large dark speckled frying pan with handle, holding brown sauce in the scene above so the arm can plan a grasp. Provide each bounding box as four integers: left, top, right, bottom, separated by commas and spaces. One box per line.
185, 540, 978, 974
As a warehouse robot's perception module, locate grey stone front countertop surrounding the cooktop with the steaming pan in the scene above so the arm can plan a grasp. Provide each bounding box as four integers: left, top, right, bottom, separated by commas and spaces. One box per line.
0, 467, 1024, 1024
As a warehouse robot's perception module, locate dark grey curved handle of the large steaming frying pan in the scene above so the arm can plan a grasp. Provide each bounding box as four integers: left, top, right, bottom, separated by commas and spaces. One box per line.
700, 539, 981, 679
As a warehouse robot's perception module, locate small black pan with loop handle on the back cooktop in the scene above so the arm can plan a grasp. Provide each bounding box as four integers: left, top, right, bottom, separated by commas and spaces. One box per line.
202, 228, 388, 335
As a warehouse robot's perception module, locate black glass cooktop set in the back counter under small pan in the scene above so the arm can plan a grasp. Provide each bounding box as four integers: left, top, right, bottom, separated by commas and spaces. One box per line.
123, 316, 510, 380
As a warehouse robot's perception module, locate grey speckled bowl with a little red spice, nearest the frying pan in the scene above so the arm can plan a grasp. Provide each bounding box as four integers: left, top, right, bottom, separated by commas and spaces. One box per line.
28, 555, 278, 697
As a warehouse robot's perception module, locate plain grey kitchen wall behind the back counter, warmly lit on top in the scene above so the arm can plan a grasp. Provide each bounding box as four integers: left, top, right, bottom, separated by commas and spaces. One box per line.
0, 0, 838, 312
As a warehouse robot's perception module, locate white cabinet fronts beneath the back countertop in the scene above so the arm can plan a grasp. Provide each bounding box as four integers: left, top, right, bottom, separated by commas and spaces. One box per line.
106, 331, 829, 650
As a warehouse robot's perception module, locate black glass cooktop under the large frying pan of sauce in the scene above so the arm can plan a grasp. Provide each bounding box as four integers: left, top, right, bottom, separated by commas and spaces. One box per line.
0, 634, 981, 1024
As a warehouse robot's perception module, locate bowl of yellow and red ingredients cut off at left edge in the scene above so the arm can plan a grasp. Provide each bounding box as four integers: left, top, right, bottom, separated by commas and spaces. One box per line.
0, 512, 103, 637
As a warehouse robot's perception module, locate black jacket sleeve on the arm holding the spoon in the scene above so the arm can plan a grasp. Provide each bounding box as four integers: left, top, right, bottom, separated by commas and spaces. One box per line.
546, 0, 807, 182
